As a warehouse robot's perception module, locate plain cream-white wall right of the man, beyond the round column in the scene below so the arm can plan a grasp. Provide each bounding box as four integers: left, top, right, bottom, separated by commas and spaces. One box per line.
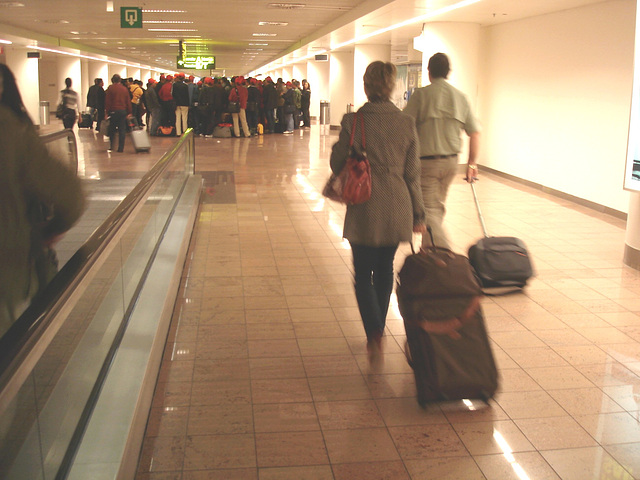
478, 0, 635, 212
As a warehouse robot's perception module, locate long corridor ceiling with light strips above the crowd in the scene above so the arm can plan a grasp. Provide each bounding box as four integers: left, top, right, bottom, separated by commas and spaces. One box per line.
0, 0, 602, 76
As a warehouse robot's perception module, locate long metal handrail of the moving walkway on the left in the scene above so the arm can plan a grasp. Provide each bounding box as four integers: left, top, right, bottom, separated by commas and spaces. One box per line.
0, 129, 194, 411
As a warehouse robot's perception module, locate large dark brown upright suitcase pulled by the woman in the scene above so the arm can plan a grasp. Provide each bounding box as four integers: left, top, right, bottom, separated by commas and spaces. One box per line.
396, 229, 498, 406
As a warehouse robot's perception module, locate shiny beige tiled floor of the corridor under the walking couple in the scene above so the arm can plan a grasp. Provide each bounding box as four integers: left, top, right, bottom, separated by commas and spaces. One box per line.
70, 122, 640, 480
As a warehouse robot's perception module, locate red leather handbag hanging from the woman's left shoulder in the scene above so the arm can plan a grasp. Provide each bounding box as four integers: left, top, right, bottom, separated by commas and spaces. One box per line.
322, 113, 371, 205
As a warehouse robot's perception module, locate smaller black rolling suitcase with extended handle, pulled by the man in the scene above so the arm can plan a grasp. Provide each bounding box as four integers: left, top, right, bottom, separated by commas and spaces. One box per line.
468, 183, 533, 293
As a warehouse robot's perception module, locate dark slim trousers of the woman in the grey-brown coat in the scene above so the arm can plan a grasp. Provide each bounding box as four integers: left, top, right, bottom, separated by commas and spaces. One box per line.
351, 243, 398, 338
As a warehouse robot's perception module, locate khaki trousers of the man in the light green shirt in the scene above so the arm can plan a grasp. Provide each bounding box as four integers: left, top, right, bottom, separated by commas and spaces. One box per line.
420, 155, 458, 249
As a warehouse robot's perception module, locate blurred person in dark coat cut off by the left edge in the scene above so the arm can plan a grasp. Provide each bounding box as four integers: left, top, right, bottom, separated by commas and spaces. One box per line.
0, 64, 85, 336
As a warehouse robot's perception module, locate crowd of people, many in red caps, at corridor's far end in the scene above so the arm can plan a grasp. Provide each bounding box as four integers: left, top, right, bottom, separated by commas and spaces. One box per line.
68, 73, 311, 142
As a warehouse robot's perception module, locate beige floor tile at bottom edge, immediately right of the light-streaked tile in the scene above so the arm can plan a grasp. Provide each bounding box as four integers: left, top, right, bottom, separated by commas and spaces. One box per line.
541, 447, 633, 480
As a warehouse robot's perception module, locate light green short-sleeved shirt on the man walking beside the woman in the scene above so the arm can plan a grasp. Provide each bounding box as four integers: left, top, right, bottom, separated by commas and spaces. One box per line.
404, 78, 480, 157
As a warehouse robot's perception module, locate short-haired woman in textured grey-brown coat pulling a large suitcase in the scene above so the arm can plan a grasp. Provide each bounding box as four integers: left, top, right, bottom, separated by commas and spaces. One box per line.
330, 61, 426, 355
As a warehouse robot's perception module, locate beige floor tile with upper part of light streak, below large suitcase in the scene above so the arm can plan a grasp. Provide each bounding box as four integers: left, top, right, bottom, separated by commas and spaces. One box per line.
453, 420, 535, 456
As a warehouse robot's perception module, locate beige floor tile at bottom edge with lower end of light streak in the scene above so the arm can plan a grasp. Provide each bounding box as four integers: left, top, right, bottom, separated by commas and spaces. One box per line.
474, 452, 560, 480
